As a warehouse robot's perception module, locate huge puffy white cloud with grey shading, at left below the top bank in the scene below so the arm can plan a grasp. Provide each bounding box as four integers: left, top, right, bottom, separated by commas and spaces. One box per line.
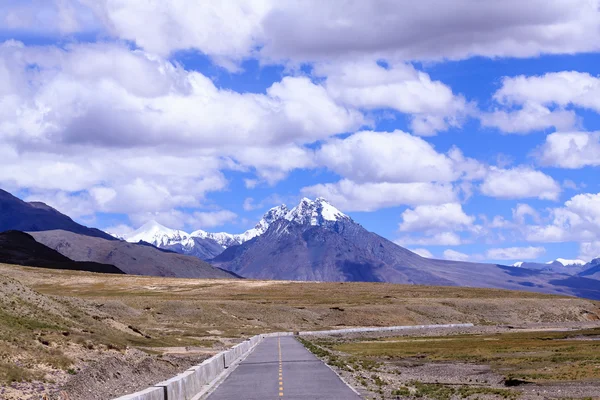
0, 43, 365, 152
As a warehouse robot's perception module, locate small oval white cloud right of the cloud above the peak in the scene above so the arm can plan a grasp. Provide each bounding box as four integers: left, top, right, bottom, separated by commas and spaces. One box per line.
481, 167, 561, 200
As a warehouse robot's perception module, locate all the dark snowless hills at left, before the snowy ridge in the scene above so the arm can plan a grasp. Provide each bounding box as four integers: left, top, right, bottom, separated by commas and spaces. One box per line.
0, 190, 238, 278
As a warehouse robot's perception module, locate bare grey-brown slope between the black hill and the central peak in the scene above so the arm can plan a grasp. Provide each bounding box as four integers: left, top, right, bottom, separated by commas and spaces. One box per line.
31, 230, 235, 278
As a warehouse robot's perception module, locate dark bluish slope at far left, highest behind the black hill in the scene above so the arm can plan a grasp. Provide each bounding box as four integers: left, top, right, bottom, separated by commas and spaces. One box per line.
0, 189, 113, 240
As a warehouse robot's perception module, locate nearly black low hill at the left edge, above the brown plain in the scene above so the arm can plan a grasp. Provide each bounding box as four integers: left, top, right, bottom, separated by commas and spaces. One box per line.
0, 231, 124, 274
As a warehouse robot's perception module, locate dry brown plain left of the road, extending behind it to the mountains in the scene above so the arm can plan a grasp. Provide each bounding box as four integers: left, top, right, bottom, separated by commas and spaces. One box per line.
0, 264, 600, 400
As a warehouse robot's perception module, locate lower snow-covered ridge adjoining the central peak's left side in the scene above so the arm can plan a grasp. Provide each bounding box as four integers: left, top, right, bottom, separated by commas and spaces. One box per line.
119, 205, 288, 260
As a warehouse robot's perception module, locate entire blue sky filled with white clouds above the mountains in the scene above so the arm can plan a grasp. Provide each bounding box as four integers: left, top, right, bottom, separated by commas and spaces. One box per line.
0, 0, 600, 264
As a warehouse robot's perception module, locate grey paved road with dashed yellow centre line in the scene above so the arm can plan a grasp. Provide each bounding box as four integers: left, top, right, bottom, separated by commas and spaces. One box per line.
208, 336, 360, 400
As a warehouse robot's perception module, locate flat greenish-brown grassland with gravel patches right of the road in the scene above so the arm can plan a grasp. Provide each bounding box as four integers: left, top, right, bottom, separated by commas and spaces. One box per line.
302, 327, 600, 400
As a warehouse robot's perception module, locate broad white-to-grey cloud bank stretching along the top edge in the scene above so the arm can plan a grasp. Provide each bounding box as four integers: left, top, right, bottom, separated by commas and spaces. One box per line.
2, 0, 600, 65
